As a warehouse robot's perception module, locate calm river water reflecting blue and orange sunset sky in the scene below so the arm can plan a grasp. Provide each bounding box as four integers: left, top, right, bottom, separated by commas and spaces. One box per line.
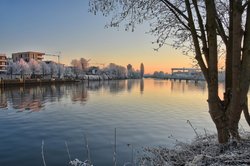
0, 79, 247, 166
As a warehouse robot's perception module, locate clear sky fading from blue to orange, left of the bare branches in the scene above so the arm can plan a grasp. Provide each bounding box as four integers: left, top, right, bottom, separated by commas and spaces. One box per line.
0, 0, 192, 73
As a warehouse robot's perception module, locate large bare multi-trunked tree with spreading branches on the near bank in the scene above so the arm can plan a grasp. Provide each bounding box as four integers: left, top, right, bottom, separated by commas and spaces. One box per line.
89, 0, 250, 143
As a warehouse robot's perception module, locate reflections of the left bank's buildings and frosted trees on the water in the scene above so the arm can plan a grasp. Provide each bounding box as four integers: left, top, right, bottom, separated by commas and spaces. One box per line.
0, 80, 144, 111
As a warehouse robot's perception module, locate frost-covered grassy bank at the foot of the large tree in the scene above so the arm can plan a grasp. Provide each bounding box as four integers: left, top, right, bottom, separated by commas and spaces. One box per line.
138, 132, 250, 166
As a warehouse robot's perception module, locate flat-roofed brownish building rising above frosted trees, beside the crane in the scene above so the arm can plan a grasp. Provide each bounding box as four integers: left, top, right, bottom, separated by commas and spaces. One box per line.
12, 51, 45, 62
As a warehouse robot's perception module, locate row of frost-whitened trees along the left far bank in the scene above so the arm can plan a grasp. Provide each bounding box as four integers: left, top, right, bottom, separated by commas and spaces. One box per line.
4, 58, 144, 79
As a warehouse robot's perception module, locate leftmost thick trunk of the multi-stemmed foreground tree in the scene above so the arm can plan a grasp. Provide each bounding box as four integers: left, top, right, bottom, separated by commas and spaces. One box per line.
206, 0, 229, 143
